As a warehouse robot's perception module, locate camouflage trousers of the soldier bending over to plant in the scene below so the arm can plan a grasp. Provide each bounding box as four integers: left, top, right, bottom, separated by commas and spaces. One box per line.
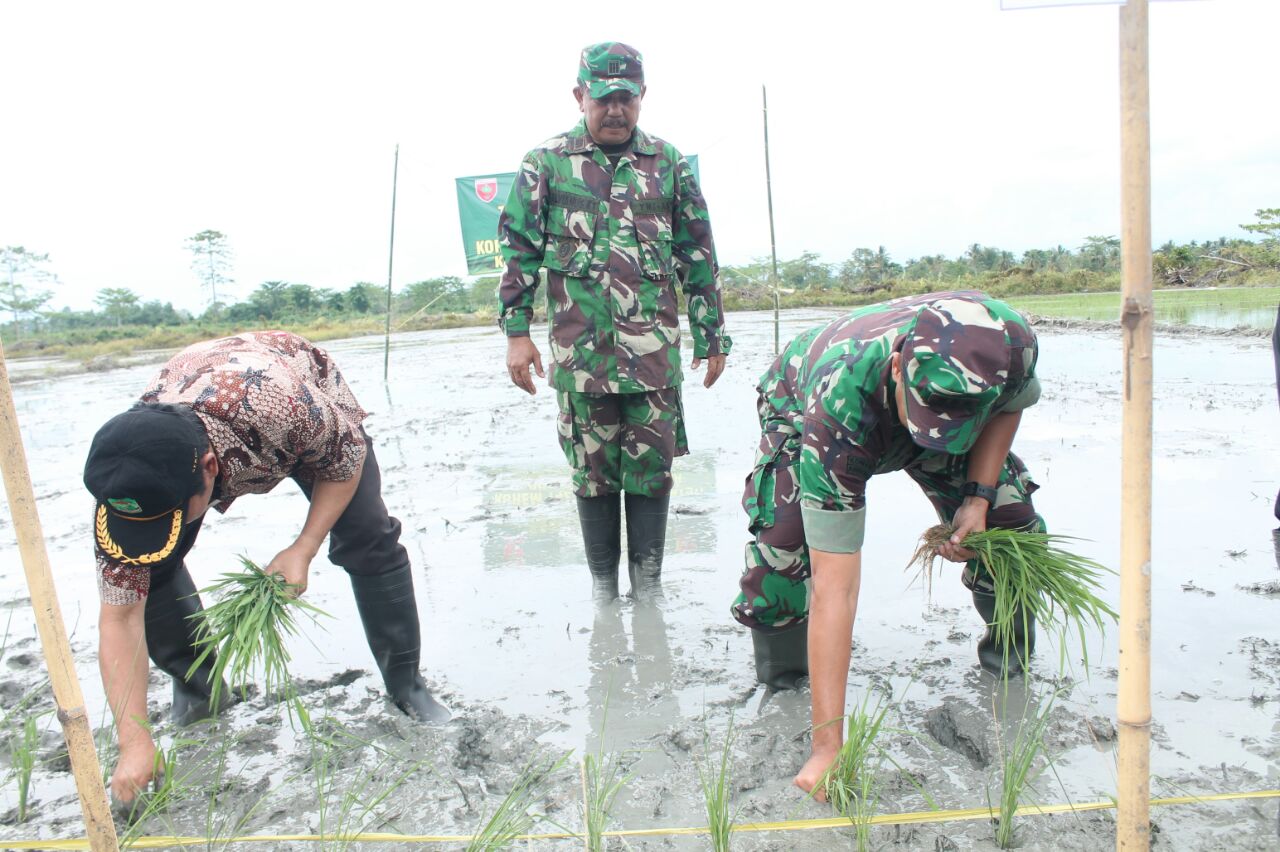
730, 435, 1044, 631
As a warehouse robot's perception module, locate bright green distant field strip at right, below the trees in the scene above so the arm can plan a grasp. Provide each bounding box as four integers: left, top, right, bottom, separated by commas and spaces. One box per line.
1006, 287, 1280, 329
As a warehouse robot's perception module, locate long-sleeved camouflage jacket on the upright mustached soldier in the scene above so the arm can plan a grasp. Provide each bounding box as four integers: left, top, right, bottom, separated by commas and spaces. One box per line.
498, 122, 730, 393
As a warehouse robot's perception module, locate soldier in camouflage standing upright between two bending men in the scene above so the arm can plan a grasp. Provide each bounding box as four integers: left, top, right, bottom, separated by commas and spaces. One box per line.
498, 42, 730, 603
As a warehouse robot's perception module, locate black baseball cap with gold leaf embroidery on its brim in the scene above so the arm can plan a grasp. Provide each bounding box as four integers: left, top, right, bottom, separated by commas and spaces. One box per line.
84, 403, 209, 567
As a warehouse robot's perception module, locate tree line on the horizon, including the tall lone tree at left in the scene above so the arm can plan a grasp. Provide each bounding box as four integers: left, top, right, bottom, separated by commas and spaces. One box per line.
0, 207, 1280, 342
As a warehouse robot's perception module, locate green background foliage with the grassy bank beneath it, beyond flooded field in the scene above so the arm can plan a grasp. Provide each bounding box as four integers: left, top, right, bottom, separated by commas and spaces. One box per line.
0, 209, 1280, 359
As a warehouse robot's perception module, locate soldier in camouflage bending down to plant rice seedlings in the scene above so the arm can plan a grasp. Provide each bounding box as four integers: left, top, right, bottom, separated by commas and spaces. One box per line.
732, 290, 1043, 794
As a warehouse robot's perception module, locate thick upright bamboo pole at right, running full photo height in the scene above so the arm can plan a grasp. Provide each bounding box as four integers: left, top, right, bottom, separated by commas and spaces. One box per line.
1116, 0, 1153, 852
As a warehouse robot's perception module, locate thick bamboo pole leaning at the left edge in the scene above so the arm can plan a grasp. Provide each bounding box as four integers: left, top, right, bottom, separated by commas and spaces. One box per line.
0, 343, 119, 852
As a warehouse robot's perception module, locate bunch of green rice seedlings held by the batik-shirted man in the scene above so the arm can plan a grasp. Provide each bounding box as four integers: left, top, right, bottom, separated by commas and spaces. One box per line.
187, 556, 328, 711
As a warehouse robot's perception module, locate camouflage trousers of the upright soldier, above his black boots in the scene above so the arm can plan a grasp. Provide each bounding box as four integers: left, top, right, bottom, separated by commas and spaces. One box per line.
556, 388, 689, 498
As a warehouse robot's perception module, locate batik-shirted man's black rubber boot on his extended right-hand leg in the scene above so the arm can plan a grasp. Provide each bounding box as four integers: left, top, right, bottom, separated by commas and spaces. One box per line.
349, 565, 453, 722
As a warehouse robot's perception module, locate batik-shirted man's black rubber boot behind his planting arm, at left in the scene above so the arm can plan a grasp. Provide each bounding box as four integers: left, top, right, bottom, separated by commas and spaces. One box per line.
143, 565, 232, 725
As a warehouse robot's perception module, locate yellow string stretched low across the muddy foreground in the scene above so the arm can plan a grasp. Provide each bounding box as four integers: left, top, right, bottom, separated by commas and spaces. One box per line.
0, 789, 1280, 849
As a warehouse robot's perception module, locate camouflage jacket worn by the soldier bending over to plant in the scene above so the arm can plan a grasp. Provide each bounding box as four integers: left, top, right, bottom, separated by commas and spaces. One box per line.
746, 290, 1039, 540
